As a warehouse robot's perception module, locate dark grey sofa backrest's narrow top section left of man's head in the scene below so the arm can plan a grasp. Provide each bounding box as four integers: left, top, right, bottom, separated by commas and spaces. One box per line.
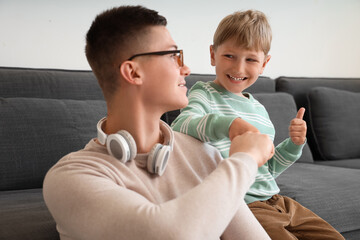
0, 67, 104, 100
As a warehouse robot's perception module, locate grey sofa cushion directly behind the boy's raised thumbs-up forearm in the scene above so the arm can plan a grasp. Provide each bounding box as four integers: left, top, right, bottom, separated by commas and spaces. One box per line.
253, 93, 314, 162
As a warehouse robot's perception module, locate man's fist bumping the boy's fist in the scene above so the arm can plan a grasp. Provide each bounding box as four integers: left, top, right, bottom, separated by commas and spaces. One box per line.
229, 132, 274, 167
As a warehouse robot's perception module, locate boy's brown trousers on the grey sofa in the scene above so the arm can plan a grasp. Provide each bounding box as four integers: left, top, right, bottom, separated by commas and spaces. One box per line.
248, 194, 344, 240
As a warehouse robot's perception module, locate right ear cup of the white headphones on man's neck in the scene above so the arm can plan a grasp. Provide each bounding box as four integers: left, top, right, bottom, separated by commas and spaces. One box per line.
147, 143, 171, 176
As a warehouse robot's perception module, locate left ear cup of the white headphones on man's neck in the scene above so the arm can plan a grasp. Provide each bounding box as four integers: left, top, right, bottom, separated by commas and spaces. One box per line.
106, 130, 137, 163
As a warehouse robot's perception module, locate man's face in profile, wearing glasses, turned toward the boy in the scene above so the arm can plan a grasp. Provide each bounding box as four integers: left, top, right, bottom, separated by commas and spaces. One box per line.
134, 26, 190, 111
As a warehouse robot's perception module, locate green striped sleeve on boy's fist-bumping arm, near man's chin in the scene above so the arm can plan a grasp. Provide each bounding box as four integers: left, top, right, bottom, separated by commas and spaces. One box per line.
171, 83, 237, 142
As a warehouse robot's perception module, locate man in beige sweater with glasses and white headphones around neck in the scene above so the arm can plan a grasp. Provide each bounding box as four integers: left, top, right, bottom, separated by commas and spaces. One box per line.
43, 6, 273, 240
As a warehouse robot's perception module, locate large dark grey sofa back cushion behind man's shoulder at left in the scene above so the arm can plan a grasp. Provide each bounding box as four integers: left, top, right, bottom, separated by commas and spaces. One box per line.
0, 98, 106, 190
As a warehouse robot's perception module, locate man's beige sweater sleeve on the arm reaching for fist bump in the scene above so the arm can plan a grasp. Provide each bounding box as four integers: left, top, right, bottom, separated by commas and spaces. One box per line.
43, 153, 268, 240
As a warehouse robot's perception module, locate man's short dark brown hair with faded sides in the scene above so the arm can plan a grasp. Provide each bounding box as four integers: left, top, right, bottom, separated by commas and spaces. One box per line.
85, 6, 167, 99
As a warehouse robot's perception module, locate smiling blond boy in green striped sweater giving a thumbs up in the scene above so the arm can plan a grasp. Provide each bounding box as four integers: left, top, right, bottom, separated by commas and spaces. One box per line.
172, 10, 343, 239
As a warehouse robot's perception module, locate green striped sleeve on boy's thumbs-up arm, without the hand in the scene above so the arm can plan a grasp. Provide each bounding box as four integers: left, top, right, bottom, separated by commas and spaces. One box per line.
268, 138, 305, 178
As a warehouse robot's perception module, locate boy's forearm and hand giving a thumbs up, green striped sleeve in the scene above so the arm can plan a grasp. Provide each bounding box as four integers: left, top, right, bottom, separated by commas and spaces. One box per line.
268, 108, 307, 178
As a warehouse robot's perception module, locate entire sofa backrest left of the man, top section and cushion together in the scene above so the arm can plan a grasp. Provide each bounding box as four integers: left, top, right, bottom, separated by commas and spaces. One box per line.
0, 67, 106, 190
